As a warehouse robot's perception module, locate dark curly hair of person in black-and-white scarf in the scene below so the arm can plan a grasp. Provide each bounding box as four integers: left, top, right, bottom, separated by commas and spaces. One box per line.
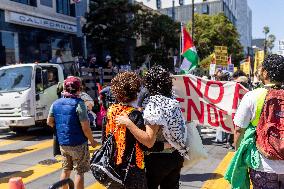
144, 66, 173, 97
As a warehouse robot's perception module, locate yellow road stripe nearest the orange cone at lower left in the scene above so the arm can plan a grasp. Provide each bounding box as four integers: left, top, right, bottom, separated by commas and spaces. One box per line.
0, 162, 62, 189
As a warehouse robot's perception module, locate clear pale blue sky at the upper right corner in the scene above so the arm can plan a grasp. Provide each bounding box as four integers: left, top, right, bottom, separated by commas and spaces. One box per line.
248, 0, 284, 51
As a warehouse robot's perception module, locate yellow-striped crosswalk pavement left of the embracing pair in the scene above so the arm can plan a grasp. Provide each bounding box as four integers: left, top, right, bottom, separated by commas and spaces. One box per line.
0, 132, 104, 189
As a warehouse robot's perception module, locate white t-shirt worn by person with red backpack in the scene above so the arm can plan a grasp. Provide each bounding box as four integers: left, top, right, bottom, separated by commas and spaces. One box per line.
234, 90, 284, 174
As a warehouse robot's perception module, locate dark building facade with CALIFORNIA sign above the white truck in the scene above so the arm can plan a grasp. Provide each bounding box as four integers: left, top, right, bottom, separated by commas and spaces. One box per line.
0, 0, 87, 66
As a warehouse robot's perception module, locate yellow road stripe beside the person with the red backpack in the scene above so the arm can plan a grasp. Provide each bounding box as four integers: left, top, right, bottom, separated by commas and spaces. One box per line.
201, 152, 234, 189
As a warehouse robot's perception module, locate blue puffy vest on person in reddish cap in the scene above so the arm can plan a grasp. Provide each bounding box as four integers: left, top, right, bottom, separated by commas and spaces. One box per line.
53, 98, 88, 146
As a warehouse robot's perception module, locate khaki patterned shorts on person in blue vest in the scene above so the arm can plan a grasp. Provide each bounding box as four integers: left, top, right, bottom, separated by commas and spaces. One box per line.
60, 144, 90, 174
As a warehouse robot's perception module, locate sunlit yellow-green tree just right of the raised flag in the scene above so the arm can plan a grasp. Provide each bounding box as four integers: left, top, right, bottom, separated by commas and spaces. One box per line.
187, 13, 244, 63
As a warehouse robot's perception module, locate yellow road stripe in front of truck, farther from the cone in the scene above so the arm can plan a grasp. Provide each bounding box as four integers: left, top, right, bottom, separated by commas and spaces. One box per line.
0, 140, 53, 162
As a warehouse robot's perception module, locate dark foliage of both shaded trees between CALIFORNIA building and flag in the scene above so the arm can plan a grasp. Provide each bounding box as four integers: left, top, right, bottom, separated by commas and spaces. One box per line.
84, 0, 179, 69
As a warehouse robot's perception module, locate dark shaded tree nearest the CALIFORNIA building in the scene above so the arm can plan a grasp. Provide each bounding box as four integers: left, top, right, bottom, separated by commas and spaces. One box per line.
83, 0, 140, 63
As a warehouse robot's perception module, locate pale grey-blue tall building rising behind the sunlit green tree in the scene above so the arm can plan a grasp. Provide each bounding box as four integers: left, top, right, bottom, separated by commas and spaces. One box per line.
137, 0, 252, 53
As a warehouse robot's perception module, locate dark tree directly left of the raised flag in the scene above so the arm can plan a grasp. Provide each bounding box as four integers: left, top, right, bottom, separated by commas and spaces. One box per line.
134, 11, 180, 70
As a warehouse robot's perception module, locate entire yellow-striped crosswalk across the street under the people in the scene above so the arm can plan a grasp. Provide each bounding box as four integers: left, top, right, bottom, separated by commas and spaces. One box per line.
0, 128, 233, 189
